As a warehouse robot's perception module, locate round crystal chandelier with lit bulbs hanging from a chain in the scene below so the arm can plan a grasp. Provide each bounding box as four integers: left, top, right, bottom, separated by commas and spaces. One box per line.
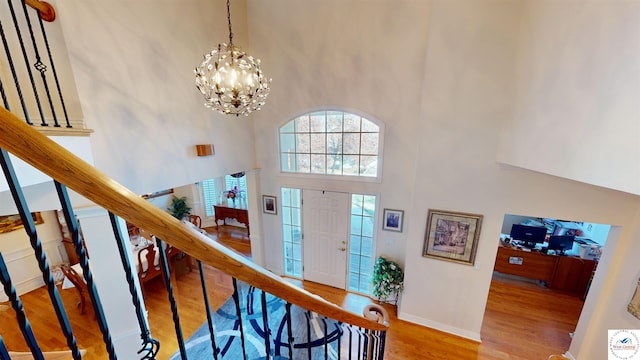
195, 0, 271, 116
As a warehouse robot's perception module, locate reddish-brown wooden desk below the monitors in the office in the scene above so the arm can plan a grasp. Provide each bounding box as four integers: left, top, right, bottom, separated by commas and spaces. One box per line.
494, 245, 598, 299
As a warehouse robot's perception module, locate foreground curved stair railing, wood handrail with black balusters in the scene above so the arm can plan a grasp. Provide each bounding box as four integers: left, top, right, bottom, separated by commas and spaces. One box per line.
0, 108, 387, 359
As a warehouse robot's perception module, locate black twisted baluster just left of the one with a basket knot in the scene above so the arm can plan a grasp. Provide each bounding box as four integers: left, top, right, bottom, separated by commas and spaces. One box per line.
54, 181, 117, 360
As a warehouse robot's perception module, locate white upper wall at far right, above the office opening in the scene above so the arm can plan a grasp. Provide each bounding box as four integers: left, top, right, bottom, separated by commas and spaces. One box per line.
500, 0, 640, 194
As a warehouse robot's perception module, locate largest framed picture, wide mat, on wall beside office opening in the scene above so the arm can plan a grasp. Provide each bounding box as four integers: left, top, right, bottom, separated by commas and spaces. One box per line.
422, 209, 482, 265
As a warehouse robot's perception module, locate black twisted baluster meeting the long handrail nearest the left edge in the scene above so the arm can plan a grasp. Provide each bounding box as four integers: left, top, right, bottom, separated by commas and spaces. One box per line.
0, 149, 81, 360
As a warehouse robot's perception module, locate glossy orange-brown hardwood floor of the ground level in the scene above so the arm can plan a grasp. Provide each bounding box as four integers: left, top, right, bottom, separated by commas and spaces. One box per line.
0, 226, 583, 360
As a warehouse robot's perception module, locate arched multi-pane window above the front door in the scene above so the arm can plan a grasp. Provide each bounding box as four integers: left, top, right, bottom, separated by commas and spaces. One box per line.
280, 111, 382, 177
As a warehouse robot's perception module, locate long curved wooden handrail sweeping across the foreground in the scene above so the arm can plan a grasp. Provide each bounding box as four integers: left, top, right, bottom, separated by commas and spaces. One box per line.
0, 107, 388, 330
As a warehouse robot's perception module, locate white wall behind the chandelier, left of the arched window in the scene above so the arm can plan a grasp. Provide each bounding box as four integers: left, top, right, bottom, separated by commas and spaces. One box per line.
55, 0, 255, 194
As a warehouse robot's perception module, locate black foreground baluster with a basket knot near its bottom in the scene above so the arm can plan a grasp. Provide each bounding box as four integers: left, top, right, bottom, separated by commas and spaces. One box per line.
109, 212, 160, 360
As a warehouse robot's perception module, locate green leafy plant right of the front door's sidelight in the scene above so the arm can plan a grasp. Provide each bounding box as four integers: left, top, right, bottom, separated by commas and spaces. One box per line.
371, 256, 404, 305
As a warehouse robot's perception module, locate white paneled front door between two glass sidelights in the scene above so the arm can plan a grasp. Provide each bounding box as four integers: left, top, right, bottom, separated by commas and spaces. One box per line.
302, 189, 349, 289
